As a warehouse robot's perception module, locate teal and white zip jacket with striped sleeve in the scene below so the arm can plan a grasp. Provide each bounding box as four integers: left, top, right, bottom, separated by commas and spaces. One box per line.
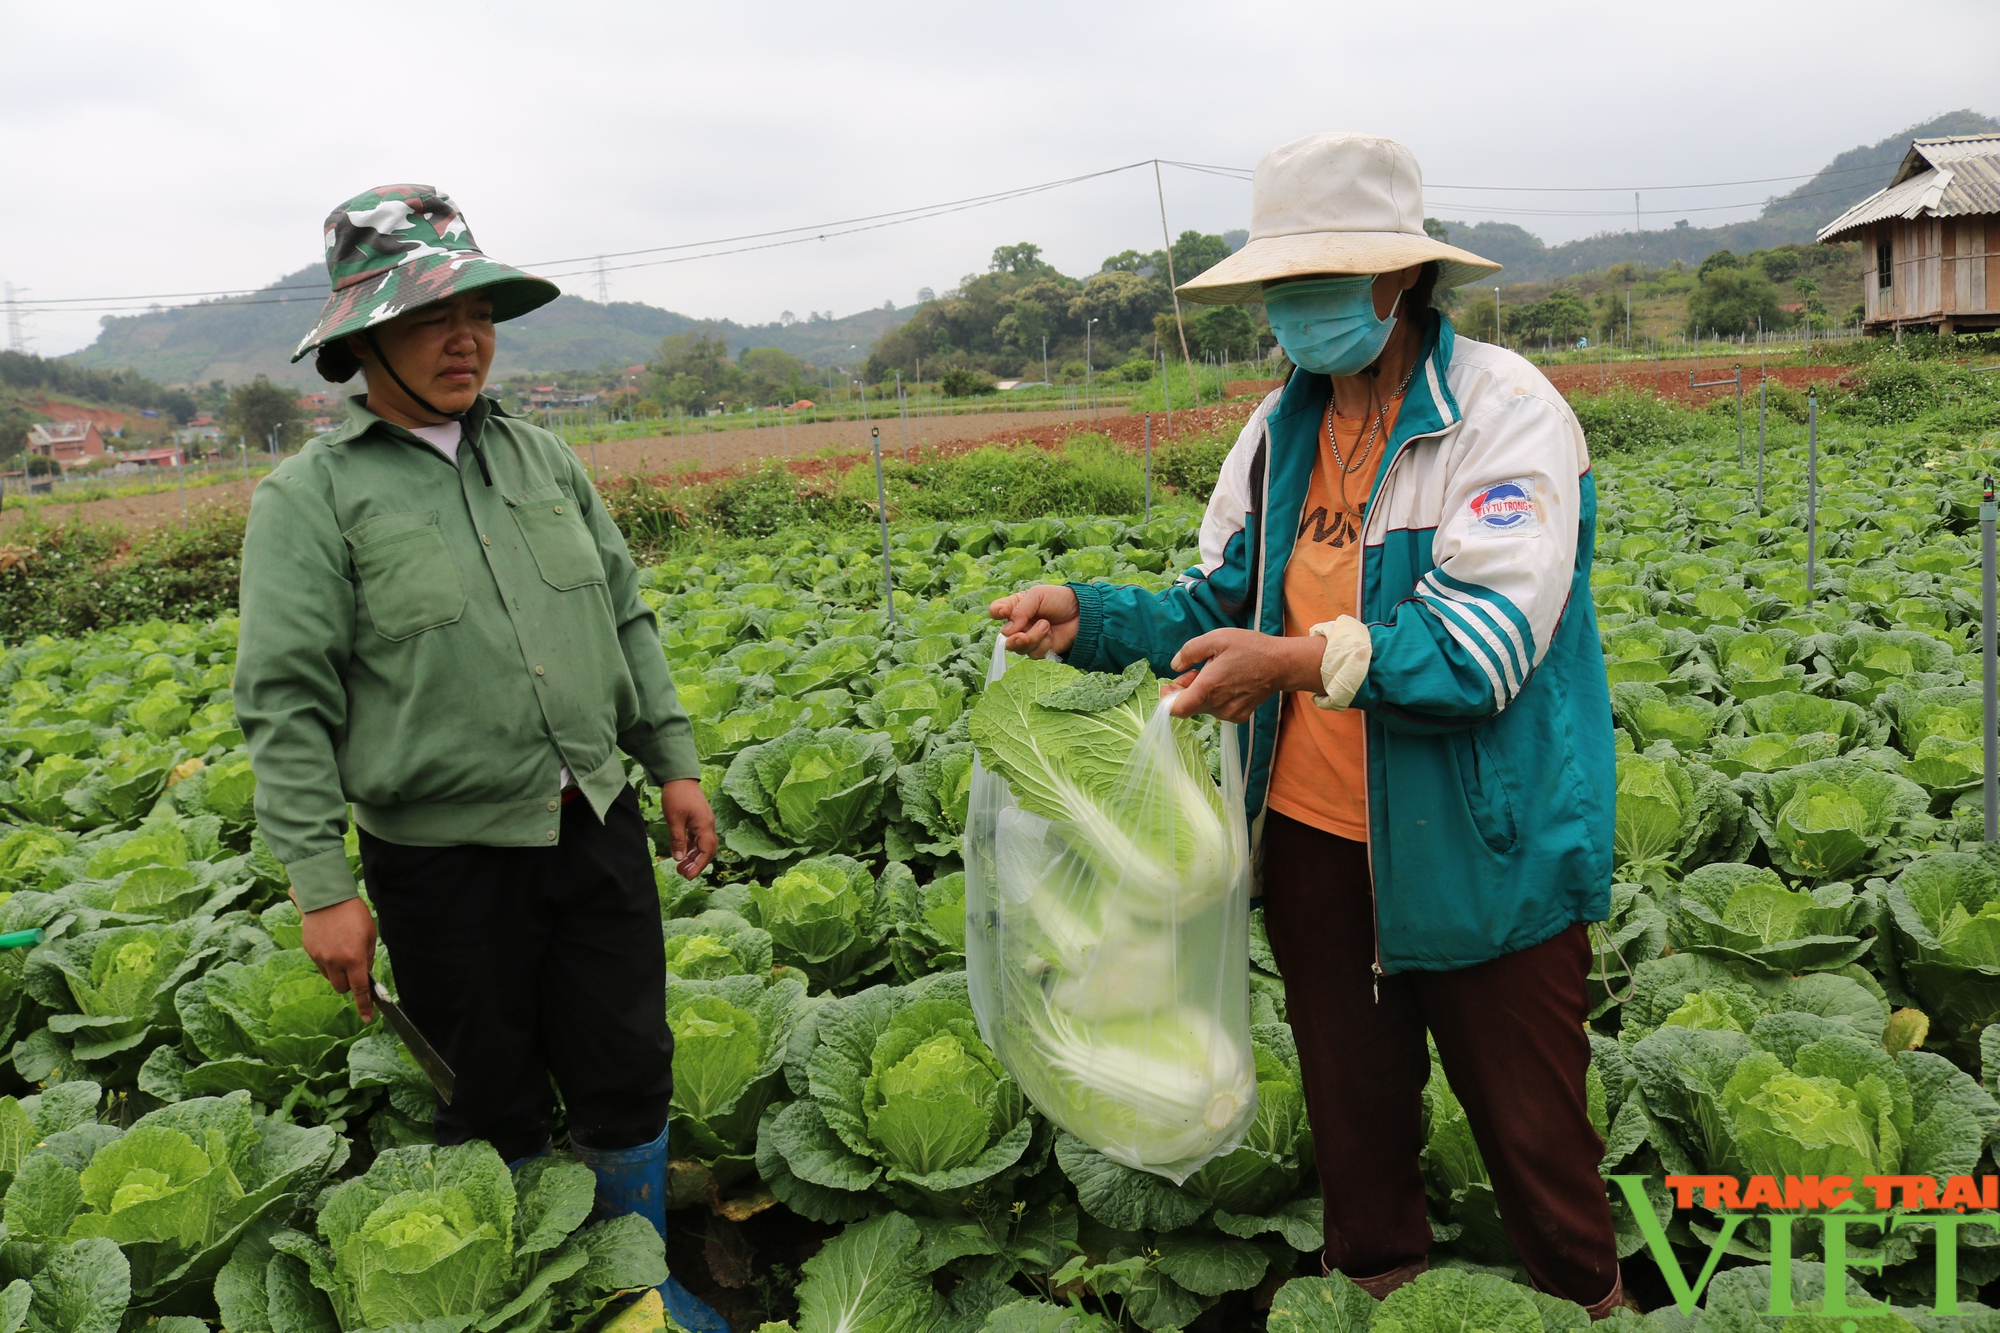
1068, 316, 1618, 973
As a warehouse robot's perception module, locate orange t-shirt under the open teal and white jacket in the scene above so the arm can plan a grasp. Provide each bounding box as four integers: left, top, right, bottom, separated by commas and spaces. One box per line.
1266, 398, 1402, 843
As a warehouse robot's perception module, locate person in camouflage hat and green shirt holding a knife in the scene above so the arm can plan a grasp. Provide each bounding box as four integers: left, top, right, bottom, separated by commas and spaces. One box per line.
236, 184, 728, 1333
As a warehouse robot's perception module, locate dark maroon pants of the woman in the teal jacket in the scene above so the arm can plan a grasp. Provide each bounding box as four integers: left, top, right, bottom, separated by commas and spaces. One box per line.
1264, 811, 1618, 1305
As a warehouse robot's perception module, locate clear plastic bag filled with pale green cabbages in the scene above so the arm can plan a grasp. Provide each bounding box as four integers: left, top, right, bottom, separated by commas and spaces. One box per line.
964, 642, 1256, 1185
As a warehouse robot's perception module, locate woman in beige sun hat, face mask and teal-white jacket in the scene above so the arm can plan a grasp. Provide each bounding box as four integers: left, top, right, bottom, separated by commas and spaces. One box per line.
992, 134, 1628, 1317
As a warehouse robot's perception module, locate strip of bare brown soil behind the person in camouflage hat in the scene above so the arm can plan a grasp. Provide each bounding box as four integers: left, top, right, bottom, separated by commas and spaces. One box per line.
0, 410, 1120, 534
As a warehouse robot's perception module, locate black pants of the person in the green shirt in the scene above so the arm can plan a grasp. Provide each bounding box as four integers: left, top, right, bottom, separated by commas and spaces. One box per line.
360, 787, 674, 1159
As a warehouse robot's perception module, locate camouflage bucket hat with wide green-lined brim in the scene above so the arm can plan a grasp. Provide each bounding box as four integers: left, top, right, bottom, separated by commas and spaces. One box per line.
292, 186, 562, 360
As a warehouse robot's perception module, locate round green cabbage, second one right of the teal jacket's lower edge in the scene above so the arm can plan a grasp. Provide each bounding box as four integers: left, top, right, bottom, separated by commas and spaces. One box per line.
1736, 759, 1936, 881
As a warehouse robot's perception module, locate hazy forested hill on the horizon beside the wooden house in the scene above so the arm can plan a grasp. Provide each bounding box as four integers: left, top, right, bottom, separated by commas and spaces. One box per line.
1444, 110, 2000, 284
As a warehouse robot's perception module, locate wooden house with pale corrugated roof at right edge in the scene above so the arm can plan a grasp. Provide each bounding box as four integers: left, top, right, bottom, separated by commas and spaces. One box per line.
1820, 134, 2000, 334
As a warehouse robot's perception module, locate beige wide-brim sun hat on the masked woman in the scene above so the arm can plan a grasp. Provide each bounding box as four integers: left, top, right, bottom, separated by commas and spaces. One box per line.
1176, 134, 1500, 306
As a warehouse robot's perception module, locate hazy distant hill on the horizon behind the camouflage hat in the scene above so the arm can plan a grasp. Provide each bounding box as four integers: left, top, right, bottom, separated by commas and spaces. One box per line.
64, 264, 916, 386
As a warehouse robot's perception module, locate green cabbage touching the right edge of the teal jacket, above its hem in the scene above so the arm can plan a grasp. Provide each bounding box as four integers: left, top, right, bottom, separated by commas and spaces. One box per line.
1612, 745, 1756, 883
